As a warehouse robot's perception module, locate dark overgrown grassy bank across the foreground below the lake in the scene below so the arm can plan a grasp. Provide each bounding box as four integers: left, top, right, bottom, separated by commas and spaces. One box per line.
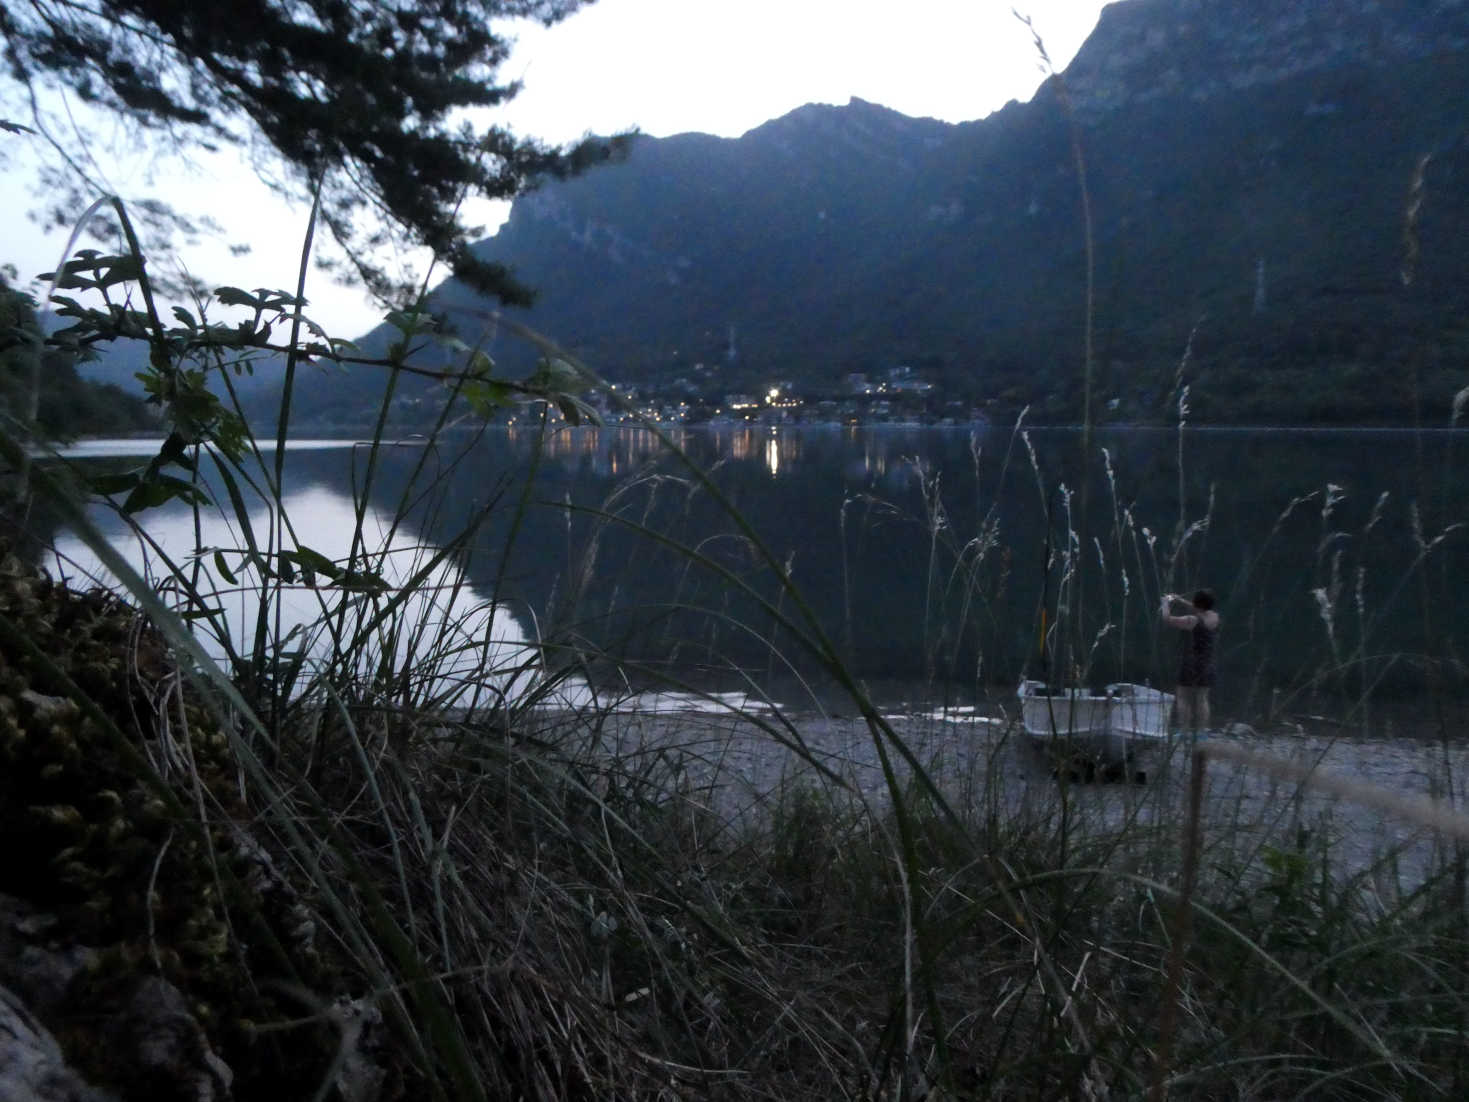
0, 560, 1469, 1099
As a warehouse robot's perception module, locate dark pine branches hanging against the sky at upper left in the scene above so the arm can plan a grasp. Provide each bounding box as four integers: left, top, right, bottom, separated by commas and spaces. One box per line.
0, 0, 624, 303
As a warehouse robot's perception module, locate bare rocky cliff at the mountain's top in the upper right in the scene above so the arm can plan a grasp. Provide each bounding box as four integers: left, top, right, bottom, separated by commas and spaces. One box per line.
1065, 0, 1469, 118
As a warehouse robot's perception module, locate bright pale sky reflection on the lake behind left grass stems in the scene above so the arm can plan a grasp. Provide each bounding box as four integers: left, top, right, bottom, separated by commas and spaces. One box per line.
56, 485, 762, 711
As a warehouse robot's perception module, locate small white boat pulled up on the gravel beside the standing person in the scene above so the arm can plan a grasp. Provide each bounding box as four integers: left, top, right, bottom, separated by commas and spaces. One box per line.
1017, 680, 1174, 780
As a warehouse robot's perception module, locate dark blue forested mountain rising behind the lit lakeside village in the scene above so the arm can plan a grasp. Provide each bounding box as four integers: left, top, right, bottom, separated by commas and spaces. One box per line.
255, 0, 1469, 423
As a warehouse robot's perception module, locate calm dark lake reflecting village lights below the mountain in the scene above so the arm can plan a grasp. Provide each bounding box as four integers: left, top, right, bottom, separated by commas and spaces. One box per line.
31, 426, 1469, 716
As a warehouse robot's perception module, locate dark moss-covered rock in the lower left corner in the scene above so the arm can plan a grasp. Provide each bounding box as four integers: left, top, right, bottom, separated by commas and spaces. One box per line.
0, 548, 392, 1101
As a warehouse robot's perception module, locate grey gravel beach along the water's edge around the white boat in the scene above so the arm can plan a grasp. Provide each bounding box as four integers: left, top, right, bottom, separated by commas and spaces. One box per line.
581, 710, 1469, 893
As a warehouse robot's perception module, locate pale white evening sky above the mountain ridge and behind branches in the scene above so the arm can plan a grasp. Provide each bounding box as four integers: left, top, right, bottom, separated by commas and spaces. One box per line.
0, 0, 1103, 336
